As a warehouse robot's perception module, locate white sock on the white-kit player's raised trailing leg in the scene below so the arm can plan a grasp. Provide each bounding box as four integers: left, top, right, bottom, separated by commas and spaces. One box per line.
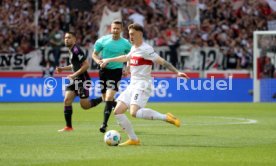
136, 108, 167, 120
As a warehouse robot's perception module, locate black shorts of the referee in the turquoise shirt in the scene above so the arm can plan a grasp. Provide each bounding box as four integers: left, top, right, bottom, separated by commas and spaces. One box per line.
99, 68, 122, 93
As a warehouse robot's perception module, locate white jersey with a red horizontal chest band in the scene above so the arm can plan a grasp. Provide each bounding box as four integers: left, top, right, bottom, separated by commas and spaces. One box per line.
126, 42, 159, 89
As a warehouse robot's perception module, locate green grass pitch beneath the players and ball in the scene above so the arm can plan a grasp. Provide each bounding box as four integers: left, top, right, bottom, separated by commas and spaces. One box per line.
0, 103, 276, 166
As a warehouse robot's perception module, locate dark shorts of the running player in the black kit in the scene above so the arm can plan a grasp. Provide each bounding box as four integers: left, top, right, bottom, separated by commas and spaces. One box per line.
66, 80, 91, 99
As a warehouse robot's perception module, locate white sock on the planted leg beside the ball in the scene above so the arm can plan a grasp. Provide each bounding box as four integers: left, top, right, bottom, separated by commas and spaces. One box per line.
115, 114, 138, 140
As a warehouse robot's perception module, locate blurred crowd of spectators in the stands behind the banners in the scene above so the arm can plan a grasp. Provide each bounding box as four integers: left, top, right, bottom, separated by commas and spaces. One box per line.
0, 0, 276, 69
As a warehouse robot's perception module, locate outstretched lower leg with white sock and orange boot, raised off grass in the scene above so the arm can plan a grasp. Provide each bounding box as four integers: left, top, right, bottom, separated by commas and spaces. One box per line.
135, 108, 181, 127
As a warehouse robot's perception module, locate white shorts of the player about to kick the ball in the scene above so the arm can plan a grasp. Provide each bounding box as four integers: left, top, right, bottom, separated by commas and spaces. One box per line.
117, 86, 151, 108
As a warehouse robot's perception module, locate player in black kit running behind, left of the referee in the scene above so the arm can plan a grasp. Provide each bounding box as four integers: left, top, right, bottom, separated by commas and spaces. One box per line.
56, 32, 102, 132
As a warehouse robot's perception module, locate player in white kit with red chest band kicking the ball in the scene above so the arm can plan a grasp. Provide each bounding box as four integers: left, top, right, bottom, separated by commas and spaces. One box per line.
101, 23, 188, 146
